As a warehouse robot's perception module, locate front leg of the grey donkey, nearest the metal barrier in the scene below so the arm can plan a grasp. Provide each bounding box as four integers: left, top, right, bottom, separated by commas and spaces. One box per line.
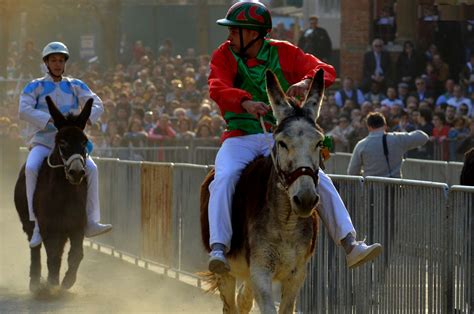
278, 265, 306, 314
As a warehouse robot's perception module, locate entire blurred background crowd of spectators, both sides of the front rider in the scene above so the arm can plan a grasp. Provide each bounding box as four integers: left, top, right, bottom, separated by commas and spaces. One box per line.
0, 0, 474, 160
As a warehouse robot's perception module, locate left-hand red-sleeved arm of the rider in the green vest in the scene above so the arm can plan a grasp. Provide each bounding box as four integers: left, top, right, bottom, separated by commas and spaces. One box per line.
208, 43, 252, 114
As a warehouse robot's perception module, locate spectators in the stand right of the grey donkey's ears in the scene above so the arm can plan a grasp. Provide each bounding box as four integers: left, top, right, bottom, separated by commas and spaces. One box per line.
328, 38, 474, 160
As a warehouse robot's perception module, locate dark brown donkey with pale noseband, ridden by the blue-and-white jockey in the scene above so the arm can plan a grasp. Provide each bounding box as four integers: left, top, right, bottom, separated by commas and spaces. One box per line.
14, 96, 93, 292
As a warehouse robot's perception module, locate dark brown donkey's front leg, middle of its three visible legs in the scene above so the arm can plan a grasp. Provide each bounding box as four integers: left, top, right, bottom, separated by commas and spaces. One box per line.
43, 233, 66, 286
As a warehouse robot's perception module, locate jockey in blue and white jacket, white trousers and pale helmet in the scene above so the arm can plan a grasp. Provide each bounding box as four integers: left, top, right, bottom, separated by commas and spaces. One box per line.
19, 42, 112, 248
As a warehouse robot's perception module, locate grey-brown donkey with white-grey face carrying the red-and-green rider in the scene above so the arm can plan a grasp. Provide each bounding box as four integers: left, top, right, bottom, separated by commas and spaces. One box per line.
201, 70, 324, 313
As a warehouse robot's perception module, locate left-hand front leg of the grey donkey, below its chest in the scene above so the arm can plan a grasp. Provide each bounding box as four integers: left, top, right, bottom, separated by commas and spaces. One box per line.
250, 265, 276, 314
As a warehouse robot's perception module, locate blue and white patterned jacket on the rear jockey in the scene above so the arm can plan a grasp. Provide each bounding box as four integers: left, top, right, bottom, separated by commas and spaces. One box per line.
19, 74, 104, 148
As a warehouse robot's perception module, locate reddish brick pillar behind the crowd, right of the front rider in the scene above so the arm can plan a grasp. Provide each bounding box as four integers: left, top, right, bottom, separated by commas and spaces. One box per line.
338, 0, 372, 81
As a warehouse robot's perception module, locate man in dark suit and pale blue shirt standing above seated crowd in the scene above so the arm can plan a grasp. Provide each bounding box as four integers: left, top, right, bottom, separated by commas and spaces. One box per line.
362, 38, 391, 91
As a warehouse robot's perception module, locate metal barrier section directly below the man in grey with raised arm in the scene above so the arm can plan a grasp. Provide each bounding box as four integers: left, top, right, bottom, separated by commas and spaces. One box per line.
364, 177, 451, 313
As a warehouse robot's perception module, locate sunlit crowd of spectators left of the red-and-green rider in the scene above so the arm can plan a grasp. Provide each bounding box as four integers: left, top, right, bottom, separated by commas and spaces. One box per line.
0, 41, 225, 158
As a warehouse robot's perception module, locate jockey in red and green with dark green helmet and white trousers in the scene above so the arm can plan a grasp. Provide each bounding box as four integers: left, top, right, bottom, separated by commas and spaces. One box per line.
208, 1, 381, 274
